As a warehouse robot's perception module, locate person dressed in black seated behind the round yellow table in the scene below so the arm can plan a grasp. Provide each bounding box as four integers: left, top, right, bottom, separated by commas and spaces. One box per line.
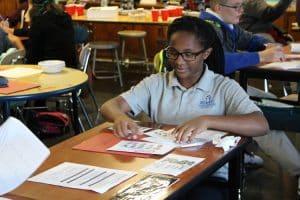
26, 0, 77, 68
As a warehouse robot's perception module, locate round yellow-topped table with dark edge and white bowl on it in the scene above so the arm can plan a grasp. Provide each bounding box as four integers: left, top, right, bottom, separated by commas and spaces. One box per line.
0, 65, 88, 133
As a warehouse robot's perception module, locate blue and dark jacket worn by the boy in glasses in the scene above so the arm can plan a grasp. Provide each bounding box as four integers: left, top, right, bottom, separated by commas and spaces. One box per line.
200, 12, 267, 74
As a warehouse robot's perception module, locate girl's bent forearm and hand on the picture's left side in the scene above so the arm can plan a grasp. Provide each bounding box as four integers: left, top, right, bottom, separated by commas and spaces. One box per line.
100, 96, 142, 137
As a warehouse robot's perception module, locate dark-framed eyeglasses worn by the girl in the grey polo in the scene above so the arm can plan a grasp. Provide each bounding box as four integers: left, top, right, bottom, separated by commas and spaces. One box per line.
165, 47, 206, 62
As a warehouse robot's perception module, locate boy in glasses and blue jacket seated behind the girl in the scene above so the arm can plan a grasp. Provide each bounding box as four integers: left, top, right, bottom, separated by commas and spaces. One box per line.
200, 0, 300, 194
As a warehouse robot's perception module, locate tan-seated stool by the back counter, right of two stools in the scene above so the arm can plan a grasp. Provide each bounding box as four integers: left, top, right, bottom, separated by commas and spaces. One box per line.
118, 30, 149, 71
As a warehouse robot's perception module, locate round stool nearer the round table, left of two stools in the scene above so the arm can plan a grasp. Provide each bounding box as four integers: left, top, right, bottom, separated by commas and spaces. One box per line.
89, 41, 123, 87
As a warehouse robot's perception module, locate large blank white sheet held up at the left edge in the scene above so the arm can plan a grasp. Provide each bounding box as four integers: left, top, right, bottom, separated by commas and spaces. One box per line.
0, 117, 50, 195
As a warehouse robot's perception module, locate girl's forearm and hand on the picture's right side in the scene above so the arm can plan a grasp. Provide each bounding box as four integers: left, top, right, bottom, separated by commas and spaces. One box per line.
174, 111, 269, 142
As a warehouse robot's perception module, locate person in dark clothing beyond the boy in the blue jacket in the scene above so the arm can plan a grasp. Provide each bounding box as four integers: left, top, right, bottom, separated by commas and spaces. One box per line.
239, 0, 293, 44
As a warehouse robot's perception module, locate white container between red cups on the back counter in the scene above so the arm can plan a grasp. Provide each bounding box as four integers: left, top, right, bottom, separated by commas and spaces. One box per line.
86, 6, 119, 19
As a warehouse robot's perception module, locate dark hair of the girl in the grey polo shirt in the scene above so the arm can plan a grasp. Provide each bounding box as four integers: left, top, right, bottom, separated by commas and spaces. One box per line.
168, 16, 224, 74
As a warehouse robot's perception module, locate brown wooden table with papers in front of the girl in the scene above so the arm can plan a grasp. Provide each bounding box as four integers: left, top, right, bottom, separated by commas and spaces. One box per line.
9, 123, 249, 200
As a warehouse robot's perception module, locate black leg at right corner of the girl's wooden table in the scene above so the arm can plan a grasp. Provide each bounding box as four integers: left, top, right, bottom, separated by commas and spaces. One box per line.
228, 151, 243, 200
